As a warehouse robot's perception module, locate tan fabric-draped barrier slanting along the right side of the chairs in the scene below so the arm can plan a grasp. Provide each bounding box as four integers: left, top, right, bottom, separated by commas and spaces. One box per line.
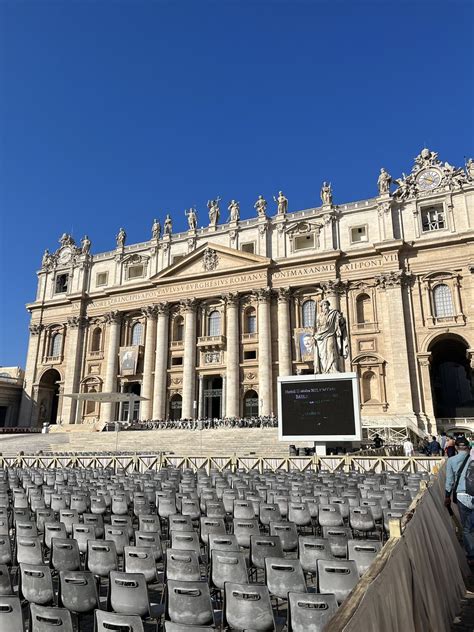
330, 467, 469, 632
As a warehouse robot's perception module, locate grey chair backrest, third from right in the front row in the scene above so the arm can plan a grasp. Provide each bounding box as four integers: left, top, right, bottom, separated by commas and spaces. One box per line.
165, 580, 214, 626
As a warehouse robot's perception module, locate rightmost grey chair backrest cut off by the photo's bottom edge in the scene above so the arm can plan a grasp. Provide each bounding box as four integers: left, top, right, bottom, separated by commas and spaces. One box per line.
287, 592, 338, 632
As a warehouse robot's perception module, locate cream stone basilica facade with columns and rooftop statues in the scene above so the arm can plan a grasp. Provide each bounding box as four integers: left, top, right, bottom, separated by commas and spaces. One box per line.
19, 149, 474, 439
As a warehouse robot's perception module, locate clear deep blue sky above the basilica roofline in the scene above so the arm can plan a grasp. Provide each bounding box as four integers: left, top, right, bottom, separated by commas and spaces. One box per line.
0, 0, 474, 366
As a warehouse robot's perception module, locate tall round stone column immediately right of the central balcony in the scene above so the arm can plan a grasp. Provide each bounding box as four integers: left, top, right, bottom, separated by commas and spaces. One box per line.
225, 294, 240, 417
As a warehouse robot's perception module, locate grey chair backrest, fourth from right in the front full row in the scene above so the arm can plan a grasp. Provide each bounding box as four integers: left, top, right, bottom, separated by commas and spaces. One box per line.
107, 571, 150, 617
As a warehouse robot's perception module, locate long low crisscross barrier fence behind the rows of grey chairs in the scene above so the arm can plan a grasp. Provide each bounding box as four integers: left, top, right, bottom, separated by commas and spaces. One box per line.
0, 453, 445, 473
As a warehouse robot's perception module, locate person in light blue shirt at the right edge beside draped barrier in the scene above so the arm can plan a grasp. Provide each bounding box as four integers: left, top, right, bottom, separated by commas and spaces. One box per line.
444, 437, 474, 568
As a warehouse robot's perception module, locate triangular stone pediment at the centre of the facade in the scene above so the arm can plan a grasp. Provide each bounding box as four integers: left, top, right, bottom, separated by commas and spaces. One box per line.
150, 242, 271, 281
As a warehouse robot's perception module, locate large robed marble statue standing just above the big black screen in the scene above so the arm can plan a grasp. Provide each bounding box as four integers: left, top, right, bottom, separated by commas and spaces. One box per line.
314, 300, 349, 373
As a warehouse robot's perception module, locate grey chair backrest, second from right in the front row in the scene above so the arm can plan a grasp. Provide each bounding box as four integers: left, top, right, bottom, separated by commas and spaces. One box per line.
223, 582, 275, 632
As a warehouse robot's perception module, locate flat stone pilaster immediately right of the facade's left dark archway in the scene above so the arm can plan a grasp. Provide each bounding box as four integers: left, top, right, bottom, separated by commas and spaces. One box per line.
58, 316, 85, 424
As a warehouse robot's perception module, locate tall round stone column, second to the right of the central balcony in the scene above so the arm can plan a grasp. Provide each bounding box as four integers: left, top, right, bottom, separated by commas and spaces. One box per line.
257, 288, 273, 415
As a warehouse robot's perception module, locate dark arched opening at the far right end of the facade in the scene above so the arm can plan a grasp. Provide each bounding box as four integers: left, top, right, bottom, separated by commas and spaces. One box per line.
429, 335, 474, 418
